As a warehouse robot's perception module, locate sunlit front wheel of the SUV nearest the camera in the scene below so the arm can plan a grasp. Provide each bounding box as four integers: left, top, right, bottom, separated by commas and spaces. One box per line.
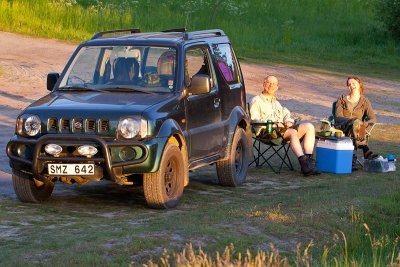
143, 143, 185, 209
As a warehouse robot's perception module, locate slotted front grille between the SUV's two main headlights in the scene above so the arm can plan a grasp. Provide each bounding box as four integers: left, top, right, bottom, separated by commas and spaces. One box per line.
47, 118, 110, 134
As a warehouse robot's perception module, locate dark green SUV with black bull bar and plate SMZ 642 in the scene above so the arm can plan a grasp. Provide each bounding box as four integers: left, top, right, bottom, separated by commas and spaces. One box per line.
7, 29, 251, 208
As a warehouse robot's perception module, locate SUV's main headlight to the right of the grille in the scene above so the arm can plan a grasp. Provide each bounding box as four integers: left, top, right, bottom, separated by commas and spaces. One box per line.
118, 117, 147, 139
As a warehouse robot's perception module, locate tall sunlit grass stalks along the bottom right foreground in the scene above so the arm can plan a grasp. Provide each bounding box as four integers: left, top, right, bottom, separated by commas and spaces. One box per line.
145, 207, 400, 267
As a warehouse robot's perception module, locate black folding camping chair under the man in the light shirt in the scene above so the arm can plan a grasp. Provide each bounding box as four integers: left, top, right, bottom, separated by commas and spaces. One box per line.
247, 104, 294, 174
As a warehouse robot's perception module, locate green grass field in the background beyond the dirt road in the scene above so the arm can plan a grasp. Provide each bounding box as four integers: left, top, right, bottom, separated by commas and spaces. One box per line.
0, 0, 400, 80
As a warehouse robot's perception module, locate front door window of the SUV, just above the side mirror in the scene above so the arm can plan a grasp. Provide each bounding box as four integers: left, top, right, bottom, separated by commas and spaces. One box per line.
185, 47, 214, 88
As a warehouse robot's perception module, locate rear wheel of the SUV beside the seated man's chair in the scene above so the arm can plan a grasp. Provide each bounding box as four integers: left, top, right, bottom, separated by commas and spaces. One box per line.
217, 128, 250, 187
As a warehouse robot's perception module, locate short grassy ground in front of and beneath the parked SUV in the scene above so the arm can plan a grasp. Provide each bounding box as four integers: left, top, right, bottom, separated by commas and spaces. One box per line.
0, 125, 400, 266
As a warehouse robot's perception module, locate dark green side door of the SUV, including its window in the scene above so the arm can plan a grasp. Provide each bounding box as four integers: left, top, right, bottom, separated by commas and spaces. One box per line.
185, 45, 225, 160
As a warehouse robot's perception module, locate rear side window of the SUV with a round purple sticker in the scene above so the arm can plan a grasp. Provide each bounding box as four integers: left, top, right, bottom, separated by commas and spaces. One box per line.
213, 44, 239, 84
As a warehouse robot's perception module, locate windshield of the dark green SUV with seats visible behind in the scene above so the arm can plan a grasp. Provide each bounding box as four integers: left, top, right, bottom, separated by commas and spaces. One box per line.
58, 46, 176, 92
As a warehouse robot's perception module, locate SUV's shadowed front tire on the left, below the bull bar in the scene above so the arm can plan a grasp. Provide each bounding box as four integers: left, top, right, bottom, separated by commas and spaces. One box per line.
12, 170, 54, 203
